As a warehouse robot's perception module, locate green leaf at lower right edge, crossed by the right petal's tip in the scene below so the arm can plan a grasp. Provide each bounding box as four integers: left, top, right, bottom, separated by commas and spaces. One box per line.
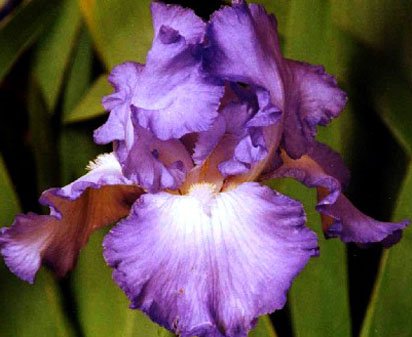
361, 162, 412, 337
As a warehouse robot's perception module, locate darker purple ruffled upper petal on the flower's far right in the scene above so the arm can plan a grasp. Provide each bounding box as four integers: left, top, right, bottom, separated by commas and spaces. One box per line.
283, 60, 347, 159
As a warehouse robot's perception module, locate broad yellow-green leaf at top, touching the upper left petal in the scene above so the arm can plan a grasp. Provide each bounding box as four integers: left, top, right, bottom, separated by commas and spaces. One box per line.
79, 0, 153, 69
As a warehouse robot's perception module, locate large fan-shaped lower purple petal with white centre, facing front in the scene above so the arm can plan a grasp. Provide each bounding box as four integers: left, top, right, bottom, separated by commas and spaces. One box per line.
104, 183, 317, 337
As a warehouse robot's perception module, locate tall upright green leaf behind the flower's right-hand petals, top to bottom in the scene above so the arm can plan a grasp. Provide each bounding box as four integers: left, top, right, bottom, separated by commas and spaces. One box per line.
282, 0, 351, 337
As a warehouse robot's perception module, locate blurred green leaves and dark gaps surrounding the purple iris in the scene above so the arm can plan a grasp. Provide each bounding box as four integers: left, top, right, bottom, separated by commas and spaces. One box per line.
0, 0, 412, 337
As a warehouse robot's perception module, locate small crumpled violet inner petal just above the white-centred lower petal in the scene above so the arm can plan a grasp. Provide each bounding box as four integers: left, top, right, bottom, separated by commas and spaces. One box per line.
193, 84, 281, 177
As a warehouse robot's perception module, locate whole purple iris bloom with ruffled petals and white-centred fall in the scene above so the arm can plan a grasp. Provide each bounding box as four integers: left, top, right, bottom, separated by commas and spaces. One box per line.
0, 1, 408, 337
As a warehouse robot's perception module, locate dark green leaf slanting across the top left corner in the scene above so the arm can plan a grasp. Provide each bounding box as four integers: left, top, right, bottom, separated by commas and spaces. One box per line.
0, 0, 59, 80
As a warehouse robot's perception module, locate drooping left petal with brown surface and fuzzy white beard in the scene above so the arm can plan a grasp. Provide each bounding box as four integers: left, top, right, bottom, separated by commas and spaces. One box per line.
0, 155, 142, 283
